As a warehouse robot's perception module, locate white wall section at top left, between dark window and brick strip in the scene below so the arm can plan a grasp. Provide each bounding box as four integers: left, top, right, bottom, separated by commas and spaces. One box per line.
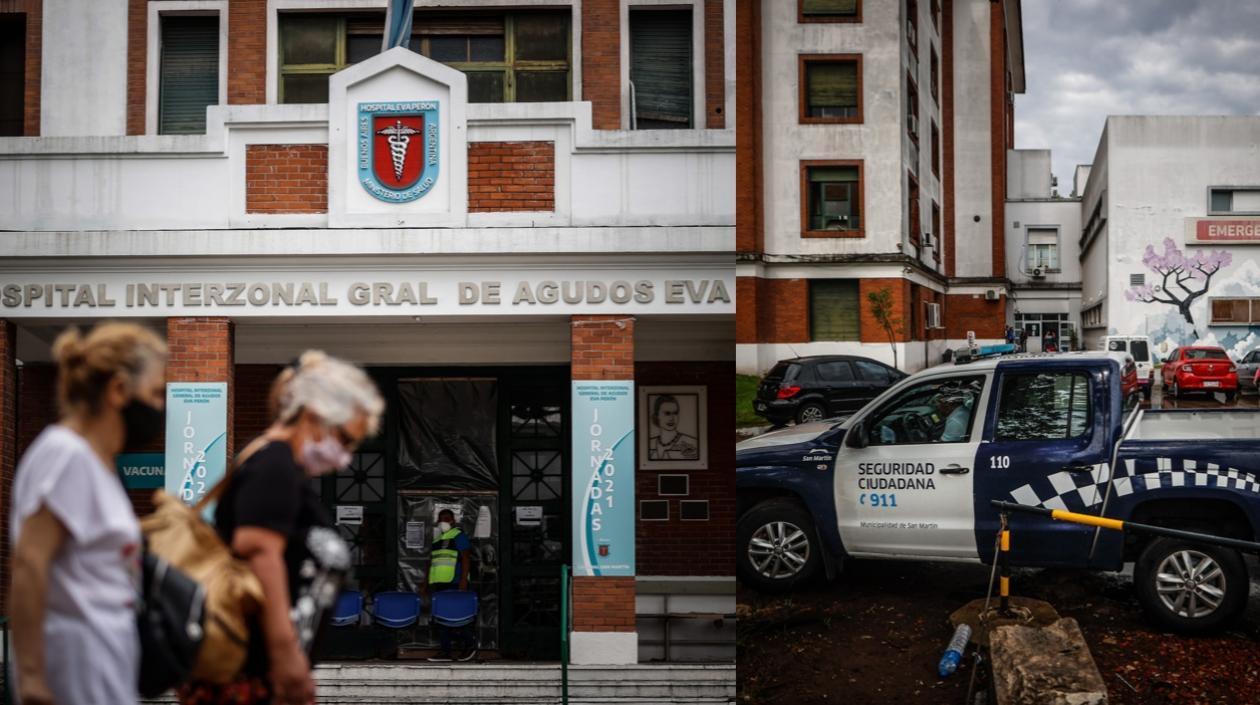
39, 0, 127, 137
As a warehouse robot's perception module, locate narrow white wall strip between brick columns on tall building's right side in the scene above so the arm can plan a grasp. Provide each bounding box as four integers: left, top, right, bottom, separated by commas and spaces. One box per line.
954, 0, 993, 277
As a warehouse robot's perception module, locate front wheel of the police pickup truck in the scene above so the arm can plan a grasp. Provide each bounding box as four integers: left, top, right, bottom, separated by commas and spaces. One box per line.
735, 499, 823, 593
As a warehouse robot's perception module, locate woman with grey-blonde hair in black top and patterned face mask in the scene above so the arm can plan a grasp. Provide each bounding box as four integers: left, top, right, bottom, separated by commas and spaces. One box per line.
180, 351, 384, 705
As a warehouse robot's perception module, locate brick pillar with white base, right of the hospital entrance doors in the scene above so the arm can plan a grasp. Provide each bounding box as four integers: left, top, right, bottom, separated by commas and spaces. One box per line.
570, 316, 639, 663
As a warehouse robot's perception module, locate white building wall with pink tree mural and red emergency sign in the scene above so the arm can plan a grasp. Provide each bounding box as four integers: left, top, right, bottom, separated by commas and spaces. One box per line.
1086, 116, 1260, 355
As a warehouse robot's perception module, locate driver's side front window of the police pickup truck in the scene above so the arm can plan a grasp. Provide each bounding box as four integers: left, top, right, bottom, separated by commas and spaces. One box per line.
866, 375, 984, 446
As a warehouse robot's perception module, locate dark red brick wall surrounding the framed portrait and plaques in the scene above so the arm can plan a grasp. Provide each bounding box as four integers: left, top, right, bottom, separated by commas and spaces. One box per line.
635, 363, 736, 575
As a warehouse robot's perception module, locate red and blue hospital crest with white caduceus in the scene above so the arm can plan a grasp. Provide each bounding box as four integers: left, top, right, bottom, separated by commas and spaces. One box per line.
357, 101, 441, 203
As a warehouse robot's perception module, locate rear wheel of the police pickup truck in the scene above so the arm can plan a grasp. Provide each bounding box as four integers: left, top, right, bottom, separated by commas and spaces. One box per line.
1133, 538, 1251, 633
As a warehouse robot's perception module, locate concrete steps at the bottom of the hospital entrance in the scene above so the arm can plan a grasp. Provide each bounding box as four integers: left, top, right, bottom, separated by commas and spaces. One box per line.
147, 663, 735, 705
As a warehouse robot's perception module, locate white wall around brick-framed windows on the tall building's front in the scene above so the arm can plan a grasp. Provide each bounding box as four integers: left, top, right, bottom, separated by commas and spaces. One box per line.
761, 0, 907, 254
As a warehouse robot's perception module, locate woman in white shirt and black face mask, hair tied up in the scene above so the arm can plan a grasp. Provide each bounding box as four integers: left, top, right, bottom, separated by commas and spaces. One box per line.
9, 324, 166, 705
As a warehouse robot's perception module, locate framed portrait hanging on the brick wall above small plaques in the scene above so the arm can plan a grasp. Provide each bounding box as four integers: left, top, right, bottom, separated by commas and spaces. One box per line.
635, 385, 708, 470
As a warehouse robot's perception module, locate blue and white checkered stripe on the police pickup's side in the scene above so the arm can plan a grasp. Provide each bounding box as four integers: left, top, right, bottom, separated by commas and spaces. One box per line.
1011, 458, 1260, 511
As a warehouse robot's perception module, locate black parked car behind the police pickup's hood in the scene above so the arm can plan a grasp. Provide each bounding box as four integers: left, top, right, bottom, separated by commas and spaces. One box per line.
752, 355, 906, 426
